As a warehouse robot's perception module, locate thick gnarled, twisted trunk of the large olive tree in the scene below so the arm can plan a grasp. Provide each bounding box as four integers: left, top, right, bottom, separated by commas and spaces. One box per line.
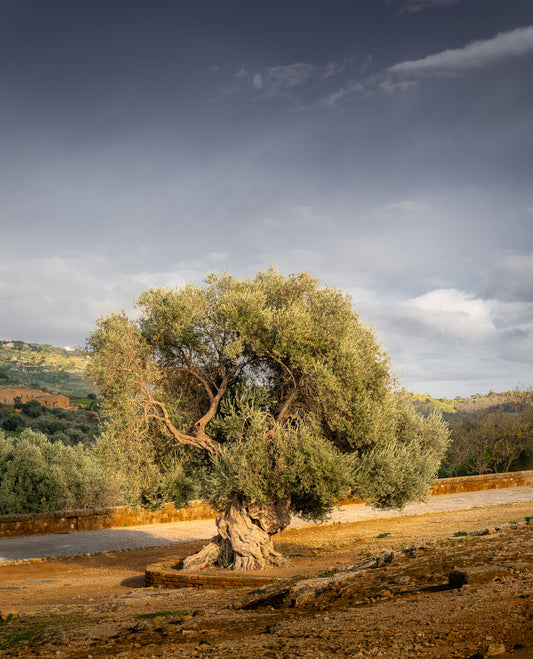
182, 498, 291, 571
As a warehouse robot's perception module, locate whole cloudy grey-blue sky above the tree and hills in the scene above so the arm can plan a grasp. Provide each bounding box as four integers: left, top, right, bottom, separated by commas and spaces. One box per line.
0, 0, 533, 397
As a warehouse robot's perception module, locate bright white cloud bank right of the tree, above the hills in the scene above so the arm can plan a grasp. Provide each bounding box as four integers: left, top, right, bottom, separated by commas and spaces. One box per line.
357, 288, 533, 397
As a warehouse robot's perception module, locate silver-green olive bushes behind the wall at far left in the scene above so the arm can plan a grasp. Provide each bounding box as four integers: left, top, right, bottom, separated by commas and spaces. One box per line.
0, 429, 114, 515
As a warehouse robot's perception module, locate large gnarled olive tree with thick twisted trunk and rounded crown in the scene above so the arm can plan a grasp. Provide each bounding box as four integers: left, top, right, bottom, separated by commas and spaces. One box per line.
88, 268, 447, 570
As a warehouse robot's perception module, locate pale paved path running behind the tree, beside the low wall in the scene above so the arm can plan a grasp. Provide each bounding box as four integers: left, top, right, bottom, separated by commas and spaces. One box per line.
0, 487, 533, 564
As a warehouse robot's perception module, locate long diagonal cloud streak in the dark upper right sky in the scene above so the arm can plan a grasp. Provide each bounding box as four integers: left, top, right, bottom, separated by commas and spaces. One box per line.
387, 25, 533, 76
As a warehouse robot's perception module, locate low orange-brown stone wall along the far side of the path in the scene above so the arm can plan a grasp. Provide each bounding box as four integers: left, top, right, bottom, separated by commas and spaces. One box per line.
0, 471, 533, 538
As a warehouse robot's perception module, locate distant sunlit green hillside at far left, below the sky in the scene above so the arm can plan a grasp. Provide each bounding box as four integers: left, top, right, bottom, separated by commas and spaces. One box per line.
0, 341, 97, 397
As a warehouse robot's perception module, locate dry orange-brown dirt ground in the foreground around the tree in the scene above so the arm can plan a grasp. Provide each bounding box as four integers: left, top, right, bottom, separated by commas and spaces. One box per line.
0, 502, 533, 659
